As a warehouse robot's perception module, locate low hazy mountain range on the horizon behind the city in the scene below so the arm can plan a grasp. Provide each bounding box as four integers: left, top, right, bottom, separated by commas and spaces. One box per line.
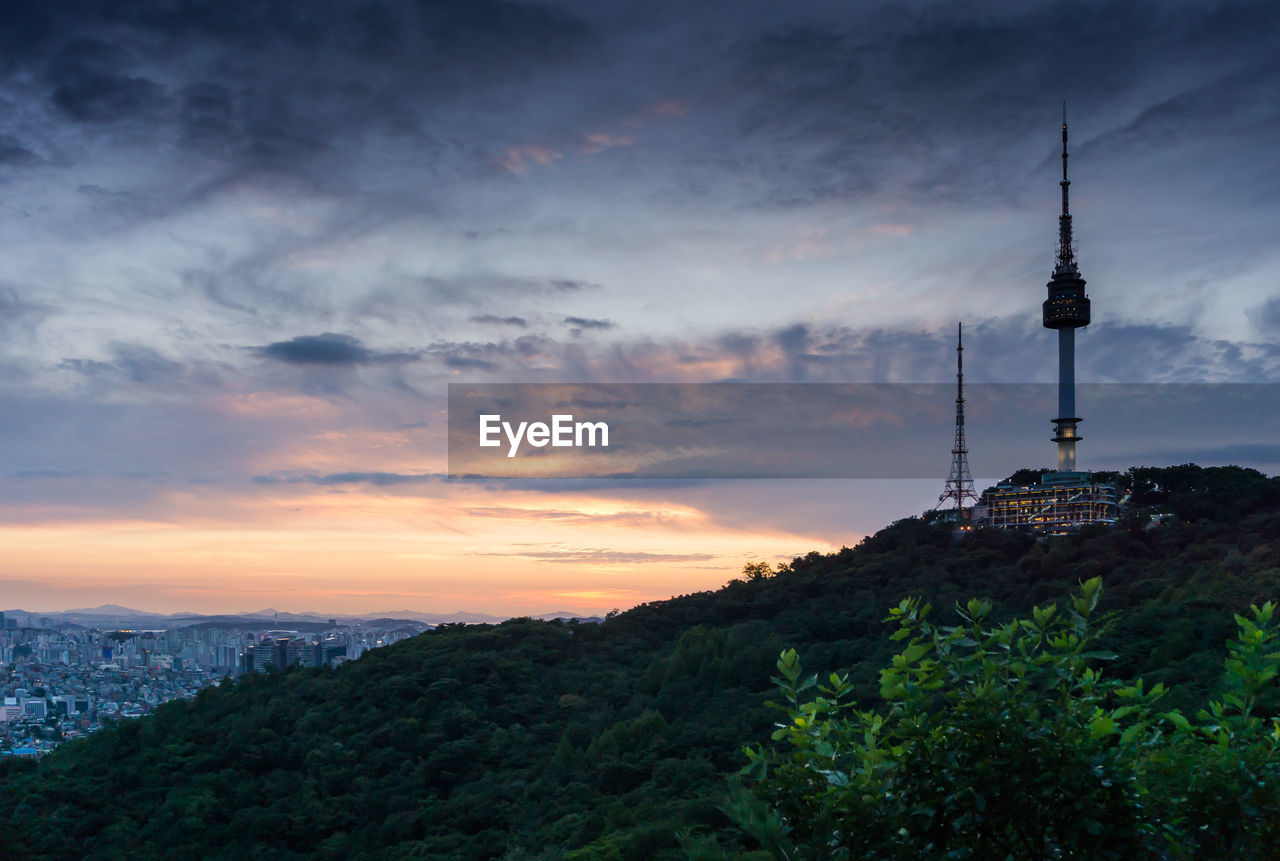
0, 604, 602, 627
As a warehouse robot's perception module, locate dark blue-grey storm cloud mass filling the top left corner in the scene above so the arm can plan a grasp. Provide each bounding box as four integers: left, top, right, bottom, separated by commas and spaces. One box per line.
0, 0, 591, 181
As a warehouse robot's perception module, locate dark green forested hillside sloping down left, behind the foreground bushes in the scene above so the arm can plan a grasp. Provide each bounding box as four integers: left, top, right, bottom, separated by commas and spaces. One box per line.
0, 467, 1280, 860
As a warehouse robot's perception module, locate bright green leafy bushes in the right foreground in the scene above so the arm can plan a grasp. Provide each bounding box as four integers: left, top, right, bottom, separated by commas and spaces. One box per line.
701, 578, 1280, 858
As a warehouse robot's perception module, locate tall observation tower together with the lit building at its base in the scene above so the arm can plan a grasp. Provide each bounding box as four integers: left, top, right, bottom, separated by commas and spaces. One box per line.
973, 106, 1120, 533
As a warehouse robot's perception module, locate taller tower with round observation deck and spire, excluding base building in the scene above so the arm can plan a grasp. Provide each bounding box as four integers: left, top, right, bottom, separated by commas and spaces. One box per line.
1043, 102, 1089, 473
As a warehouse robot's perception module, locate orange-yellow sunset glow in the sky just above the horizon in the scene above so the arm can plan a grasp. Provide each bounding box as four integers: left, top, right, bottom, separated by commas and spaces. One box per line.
0, 481, 849, 615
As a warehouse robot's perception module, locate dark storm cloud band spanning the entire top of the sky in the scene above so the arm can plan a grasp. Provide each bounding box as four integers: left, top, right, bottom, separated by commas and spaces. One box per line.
0, 0, 1280, 208
